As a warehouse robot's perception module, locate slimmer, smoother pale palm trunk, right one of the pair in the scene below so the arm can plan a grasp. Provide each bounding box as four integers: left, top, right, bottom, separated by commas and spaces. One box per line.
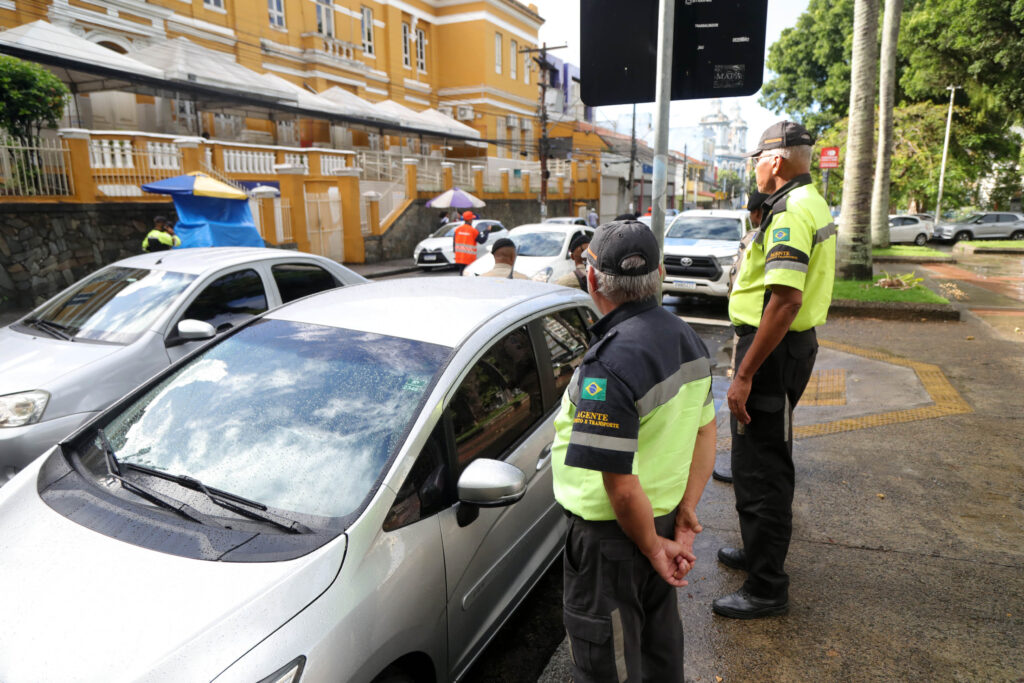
871, 0, 903, 249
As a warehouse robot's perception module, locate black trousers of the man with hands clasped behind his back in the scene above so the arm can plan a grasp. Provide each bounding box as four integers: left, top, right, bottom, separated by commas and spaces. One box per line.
562, 511, 683, 683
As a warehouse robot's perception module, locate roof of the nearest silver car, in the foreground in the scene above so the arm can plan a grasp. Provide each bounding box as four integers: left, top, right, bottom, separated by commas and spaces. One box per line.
265, 278, 586, 347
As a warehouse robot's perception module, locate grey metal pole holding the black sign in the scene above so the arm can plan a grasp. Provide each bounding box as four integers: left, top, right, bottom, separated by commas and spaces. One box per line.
650, 0, 676, 266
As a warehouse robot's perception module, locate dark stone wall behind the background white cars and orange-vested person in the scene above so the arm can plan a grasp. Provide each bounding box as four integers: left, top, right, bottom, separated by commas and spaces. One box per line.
365, 200, 570, 263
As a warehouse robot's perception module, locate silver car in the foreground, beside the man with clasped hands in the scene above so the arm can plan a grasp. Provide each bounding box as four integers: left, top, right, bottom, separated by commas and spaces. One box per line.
0, 278, 594, 683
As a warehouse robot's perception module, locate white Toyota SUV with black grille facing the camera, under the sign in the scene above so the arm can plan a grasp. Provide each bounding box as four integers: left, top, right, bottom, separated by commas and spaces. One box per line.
663, 209, 751, 297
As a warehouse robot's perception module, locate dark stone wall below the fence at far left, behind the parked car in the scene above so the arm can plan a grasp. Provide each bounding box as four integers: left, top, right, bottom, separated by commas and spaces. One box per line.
0, 202, 174, 310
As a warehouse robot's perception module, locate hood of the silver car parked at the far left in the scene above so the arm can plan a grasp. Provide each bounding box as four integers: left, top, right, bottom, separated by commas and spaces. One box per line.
0, 328, 124, 396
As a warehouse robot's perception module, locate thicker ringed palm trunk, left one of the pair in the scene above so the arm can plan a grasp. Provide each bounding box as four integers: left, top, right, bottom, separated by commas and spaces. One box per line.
837, 0, 879, 280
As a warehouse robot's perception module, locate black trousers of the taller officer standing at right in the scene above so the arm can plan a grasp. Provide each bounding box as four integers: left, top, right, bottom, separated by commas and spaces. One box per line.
731, 328, 818, 599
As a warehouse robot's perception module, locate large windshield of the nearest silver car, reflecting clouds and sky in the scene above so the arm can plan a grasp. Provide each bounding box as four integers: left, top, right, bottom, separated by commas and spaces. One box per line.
95, 319, 451, 518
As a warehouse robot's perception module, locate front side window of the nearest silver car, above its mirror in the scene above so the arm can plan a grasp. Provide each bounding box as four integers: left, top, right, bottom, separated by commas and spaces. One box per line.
449, 327, 544, 478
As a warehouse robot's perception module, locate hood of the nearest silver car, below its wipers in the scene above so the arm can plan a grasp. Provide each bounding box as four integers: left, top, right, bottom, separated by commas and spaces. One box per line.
0, 458, 345, 681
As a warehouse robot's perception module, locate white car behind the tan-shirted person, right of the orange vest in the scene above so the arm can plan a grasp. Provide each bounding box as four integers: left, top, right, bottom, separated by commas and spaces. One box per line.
462, 223, 594, 283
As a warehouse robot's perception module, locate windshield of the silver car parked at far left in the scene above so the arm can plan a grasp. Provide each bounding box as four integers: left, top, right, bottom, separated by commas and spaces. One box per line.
26, 266, 196, 344
